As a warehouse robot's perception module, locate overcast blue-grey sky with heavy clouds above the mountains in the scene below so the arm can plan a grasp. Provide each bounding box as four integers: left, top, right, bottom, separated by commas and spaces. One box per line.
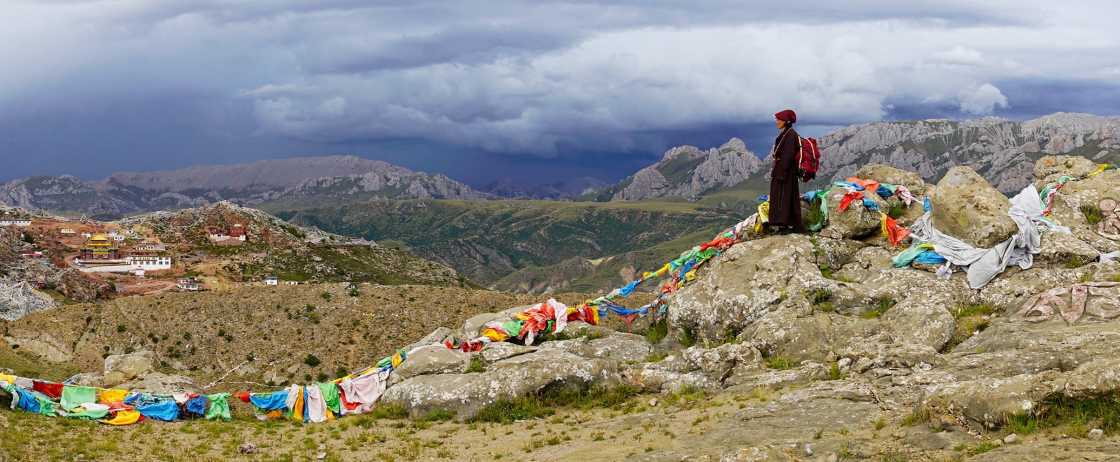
0, 0, 1120, 184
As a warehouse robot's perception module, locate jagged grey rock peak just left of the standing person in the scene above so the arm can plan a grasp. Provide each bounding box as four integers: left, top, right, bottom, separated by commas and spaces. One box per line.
610, 138, 766, 201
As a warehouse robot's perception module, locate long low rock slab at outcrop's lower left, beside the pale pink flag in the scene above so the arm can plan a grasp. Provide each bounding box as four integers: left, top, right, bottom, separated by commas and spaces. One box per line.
381, 349, 620, 419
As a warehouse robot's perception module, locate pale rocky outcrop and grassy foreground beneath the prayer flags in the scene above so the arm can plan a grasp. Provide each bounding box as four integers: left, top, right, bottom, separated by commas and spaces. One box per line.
0, 157, 1120, 461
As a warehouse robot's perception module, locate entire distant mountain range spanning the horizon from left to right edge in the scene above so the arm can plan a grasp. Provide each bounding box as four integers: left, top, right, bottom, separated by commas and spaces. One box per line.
0, 113, 1120, 219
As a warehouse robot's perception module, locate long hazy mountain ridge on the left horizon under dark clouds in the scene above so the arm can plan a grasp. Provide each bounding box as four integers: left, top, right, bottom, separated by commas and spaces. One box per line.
0, 156, 492, 219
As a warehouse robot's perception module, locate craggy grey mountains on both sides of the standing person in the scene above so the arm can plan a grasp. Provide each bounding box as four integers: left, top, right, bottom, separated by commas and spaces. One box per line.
595, 112, 1120, 201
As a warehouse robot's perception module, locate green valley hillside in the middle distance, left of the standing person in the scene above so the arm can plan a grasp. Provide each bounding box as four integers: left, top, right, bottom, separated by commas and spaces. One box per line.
262, 197, 747, 284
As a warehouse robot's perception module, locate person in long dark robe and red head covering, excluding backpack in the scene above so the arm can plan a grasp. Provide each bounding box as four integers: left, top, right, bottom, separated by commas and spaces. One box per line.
767, 109, 805, 233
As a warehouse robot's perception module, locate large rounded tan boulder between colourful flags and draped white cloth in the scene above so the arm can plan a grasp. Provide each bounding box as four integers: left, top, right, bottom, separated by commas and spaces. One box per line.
930, 166, 1018, 248
